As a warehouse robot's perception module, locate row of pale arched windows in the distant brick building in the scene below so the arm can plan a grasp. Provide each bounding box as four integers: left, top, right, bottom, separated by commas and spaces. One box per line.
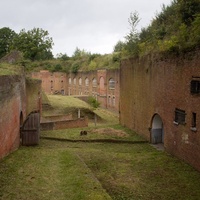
69, 77, 115, 89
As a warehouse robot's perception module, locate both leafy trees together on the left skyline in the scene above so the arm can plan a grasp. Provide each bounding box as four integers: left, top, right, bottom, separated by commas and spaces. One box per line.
0, 27, 53, 61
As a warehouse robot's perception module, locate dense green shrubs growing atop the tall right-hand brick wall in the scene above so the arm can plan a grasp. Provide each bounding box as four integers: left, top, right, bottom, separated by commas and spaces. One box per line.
114, 0, 200, 56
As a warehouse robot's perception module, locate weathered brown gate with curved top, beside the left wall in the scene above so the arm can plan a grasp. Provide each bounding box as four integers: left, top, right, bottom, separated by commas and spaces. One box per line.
20, 112, 40, 146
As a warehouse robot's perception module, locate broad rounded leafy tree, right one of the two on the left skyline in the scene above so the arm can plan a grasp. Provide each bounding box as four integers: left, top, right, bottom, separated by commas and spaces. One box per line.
13, 28, 53, 61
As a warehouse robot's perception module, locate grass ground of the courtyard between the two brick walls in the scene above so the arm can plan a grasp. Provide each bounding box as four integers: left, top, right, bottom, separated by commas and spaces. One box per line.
0, 97, 200, 200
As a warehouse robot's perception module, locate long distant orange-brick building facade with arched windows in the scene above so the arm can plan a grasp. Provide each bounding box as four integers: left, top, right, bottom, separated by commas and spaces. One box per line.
32, 70, 120, 112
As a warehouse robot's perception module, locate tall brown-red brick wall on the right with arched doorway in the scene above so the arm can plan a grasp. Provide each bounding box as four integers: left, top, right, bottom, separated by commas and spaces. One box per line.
120, 52, 200, 170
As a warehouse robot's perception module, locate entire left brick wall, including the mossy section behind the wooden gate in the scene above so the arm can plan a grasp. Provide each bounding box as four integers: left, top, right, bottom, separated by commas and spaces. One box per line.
0, 74, 41, 158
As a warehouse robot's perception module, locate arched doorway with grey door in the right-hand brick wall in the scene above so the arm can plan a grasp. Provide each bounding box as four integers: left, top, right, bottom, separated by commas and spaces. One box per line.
151, 114, 164, 144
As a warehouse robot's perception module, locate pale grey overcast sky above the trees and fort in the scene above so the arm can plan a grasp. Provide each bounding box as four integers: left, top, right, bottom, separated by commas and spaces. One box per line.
0, 0, 171, 56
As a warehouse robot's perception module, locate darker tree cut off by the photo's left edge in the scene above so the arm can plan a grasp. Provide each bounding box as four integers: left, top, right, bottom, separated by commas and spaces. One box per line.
0, 27, 17, 58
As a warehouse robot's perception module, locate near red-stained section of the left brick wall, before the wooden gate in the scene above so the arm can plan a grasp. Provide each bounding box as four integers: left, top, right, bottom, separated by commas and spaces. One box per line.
0, 75, 26, 158
